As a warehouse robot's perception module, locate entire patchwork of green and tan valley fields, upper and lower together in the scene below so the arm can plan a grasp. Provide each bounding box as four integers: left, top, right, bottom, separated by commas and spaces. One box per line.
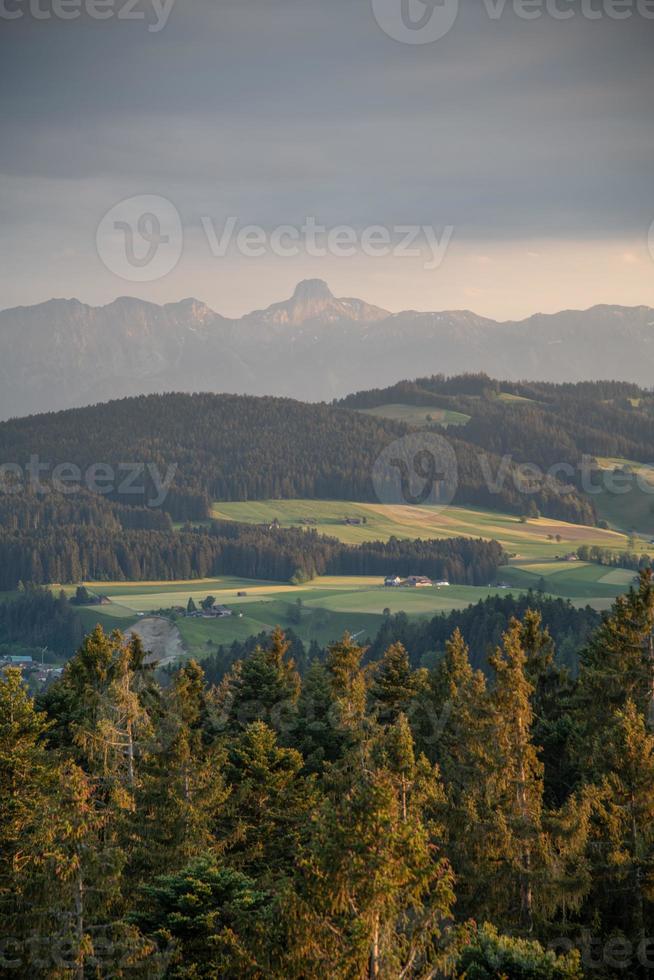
34, 500, 646, 657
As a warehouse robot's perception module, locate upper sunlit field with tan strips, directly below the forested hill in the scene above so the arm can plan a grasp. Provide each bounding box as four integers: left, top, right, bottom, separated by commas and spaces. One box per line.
213, 500, 647, 558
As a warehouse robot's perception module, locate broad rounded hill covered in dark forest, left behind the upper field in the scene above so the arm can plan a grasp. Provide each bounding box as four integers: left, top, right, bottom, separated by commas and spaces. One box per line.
0, 394, 595, 529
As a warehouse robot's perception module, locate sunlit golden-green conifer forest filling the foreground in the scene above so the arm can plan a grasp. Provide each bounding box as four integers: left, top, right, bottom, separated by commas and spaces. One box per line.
0, 571, 654, 980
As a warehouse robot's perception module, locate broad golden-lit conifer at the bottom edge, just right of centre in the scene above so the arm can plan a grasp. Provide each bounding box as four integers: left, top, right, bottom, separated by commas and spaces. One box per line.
296, 720, 454, 980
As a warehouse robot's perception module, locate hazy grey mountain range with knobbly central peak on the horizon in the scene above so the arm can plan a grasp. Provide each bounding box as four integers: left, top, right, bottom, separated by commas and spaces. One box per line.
0, 280, 654, 418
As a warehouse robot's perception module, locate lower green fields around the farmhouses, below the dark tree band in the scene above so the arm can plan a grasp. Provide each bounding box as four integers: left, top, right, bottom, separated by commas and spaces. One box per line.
52, 557, 634, 657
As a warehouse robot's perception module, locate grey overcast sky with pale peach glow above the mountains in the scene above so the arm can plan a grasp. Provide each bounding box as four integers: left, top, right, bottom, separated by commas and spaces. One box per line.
0, 0, 654, 318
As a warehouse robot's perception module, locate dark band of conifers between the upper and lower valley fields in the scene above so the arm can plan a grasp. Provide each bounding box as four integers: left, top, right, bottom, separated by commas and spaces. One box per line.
0, 521, 506, 591
